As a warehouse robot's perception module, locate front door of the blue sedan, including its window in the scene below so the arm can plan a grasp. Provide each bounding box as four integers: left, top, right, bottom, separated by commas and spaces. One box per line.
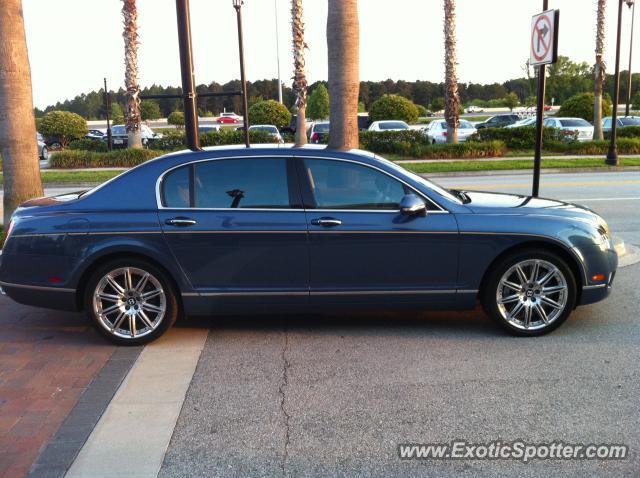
299, 159, 459, 303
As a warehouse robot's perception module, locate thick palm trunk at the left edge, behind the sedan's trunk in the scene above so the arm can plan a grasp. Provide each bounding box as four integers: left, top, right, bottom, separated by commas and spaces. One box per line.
0, 0, 42, 225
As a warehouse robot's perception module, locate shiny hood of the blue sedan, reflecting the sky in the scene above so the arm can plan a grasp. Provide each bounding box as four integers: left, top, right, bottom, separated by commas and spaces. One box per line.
464, 190, 604, 226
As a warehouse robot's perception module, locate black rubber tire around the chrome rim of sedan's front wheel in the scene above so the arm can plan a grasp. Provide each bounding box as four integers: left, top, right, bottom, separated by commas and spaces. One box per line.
480, 249, 577, 337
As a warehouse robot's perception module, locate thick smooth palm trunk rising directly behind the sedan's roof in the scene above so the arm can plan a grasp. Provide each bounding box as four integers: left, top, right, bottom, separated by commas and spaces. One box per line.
327, 0, 360, 150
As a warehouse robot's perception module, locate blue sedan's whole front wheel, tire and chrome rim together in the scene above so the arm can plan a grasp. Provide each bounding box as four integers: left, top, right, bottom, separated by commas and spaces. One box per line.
481, 249, 576, 336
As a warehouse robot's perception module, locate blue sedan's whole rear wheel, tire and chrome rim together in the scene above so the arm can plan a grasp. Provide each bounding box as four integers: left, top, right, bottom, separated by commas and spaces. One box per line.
85, 259, 178, 345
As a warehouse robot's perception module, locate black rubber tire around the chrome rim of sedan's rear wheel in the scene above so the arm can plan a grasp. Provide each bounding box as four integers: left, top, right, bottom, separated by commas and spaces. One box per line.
84, 258, 179, 345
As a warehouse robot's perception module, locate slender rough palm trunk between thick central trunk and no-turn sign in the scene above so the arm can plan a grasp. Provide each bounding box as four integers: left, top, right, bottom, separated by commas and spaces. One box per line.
444, 0, 460, 143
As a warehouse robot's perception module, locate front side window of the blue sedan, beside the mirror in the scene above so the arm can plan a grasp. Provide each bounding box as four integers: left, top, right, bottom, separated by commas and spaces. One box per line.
305, 159, 412, 210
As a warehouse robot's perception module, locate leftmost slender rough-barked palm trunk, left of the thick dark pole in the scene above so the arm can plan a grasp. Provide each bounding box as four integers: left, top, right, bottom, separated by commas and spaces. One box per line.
122, 0, 142, 148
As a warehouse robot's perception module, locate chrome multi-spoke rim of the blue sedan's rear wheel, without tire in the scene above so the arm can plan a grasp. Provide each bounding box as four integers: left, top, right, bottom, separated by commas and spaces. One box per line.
93, 267, 167, 339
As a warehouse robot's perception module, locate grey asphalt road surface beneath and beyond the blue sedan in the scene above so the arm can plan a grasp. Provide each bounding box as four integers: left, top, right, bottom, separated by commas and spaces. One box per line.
159, 173, 640, 477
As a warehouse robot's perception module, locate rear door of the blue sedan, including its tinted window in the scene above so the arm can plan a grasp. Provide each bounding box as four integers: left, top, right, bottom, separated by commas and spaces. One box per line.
158, 157, 309, 303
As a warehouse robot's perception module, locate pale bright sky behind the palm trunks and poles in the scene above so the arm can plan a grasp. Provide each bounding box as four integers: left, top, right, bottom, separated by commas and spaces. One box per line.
23, 0, 640, 108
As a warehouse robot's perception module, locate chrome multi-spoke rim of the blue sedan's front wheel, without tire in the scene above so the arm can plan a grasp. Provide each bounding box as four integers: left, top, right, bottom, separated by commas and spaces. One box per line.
496, 259, 568, 330
